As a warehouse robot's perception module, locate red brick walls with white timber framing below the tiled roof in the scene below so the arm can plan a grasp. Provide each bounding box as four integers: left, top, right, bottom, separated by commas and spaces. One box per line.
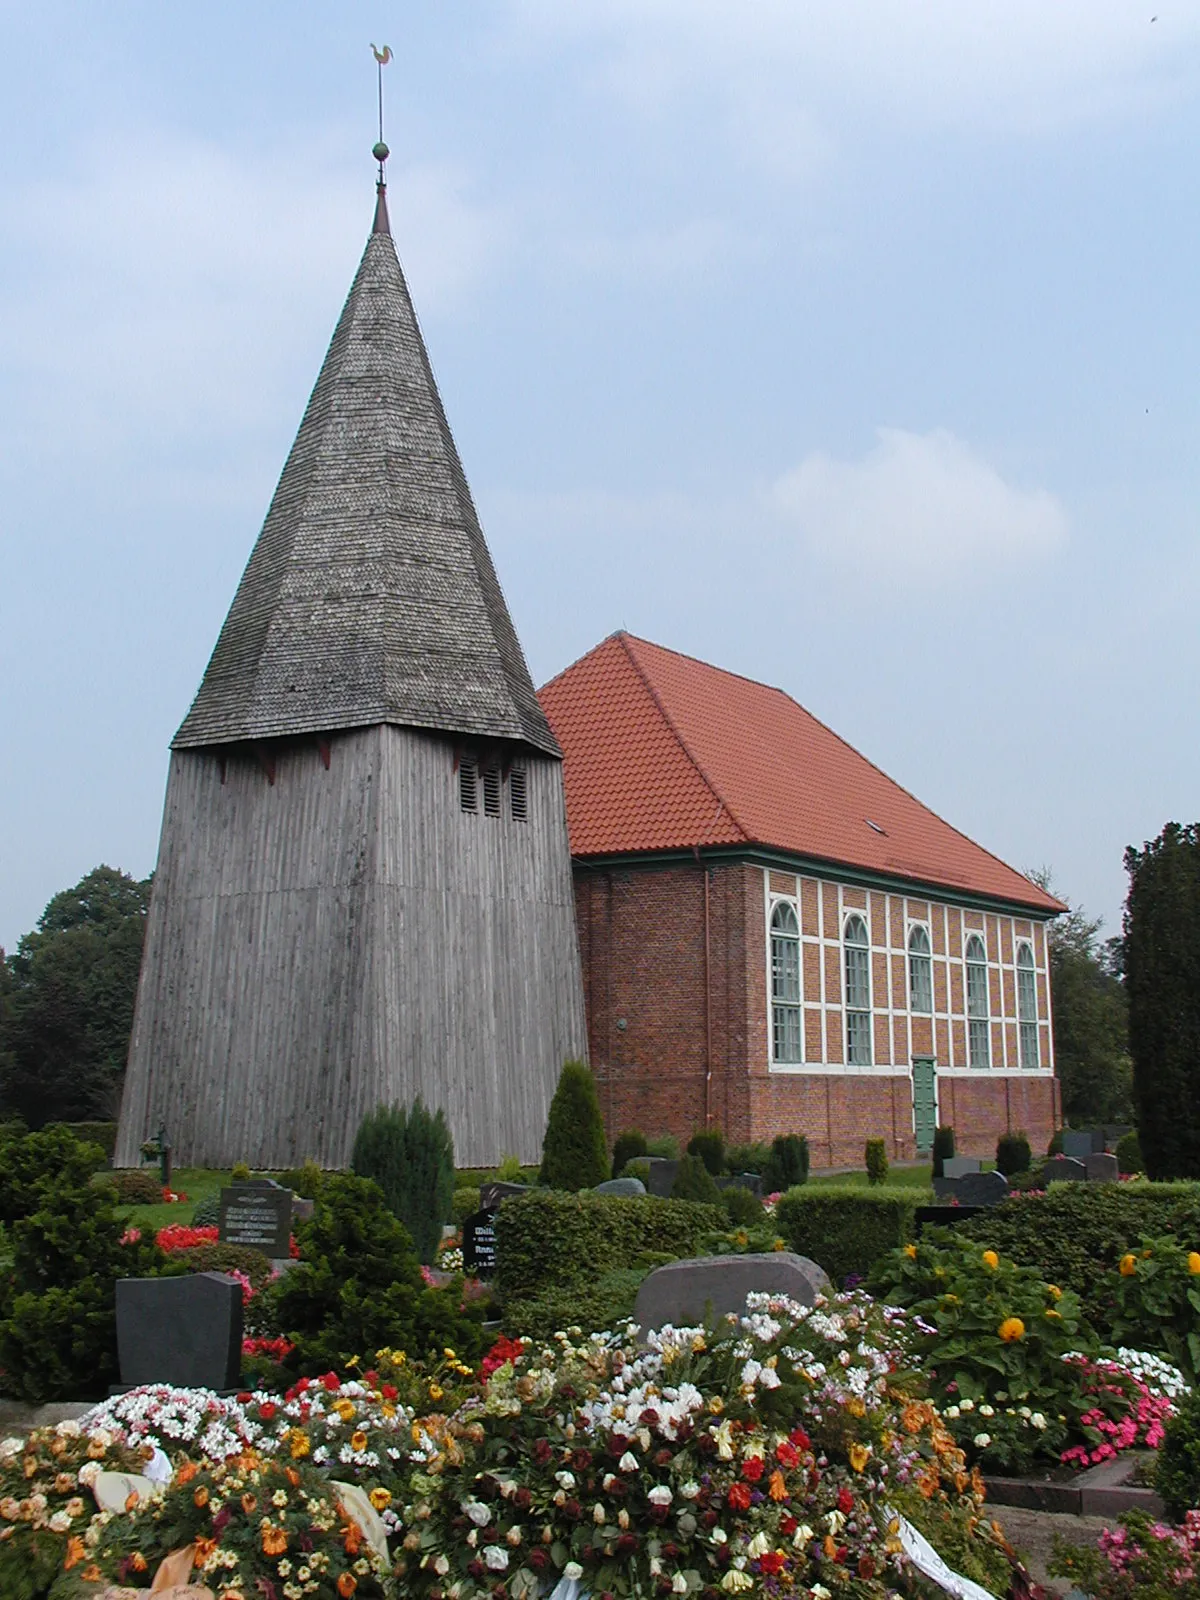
574, 861, 1058, 1166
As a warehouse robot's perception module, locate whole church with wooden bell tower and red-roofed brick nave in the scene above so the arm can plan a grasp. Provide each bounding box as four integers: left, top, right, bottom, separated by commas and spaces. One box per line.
117, 152, 1062, 1168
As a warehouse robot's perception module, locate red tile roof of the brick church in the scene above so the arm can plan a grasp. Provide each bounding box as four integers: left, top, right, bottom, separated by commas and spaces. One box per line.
538, 634, 1064, 914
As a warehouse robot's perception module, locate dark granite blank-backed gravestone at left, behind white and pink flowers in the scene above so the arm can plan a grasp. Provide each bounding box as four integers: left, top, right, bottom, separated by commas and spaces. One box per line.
117, 1272, 242, 1392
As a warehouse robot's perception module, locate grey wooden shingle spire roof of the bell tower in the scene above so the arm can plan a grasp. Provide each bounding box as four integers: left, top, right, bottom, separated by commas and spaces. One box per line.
173, 189, 560, 755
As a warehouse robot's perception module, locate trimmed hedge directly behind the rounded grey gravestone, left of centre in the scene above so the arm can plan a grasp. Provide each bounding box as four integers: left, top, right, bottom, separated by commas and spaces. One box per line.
496, 1189, 728, 1322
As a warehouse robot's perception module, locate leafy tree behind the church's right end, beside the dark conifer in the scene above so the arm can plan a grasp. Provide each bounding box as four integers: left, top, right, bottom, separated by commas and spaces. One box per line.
1032, 870, 1133, 1125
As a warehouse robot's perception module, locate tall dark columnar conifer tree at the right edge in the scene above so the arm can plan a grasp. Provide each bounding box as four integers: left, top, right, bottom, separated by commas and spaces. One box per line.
1123, 822, 1200, 1178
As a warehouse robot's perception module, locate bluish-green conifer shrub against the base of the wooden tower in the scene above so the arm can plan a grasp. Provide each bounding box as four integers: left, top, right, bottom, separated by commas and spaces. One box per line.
350, 1094, 454, 1266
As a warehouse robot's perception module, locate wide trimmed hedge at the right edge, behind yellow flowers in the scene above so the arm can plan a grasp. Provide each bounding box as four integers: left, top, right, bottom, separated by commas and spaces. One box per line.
957, 1182, 1200, 1328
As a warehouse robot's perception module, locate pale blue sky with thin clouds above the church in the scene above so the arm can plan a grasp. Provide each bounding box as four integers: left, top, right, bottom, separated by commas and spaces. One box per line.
0, 0, 1200, 950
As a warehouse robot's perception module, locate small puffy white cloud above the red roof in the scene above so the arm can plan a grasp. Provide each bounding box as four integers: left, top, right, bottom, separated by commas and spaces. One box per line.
766, 427, 1067, 587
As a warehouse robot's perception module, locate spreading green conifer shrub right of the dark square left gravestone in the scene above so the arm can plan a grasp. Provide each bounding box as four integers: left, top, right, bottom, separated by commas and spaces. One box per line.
262, 1173, 483, 1378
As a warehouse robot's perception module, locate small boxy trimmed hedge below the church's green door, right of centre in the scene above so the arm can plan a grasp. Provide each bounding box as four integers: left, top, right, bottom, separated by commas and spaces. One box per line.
774, 1184, 926, 1285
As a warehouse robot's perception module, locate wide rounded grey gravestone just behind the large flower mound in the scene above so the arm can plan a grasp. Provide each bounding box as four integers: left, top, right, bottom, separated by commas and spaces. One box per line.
634, 1250, 830, 1334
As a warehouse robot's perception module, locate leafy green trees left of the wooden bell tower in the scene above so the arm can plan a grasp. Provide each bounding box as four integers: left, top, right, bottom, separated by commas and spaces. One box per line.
0, 867, 150, 1128
